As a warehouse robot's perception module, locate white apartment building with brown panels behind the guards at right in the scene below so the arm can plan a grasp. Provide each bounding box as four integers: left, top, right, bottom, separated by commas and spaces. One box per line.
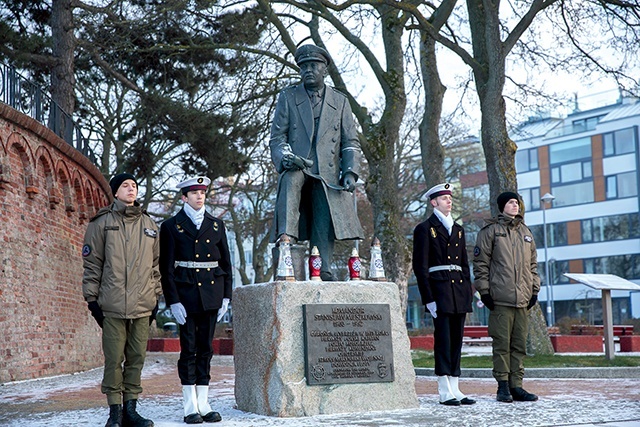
502, 98, 640, 323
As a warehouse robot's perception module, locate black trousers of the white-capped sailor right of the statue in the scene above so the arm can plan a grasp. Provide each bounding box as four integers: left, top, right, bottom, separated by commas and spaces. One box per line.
433, 313, 467, 377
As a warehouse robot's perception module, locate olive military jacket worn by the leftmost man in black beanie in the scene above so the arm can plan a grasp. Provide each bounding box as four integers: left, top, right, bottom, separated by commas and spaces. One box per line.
82, 200, 162, 319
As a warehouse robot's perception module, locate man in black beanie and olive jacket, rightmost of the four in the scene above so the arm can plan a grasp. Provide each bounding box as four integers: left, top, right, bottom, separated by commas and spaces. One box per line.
473, 191, 540, 402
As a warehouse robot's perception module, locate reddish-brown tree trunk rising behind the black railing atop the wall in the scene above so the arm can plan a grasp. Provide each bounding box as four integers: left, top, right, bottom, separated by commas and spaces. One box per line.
49, 0, 76, 142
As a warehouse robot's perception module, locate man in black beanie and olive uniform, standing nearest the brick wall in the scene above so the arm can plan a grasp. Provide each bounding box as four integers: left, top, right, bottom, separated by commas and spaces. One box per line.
82, 173, 162, 427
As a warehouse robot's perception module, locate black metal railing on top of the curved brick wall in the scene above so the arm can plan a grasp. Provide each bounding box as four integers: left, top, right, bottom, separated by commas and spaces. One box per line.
0, 64, 97, 165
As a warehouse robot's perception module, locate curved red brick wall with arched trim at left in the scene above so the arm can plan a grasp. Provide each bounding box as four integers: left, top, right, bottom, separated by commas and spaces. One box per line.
0, 103, 110, 383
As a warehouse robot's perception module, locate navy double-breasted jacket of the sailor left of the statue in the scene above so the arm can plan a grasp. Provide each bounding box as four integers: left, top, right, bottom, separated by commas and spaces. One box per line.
160, 209, 233, 313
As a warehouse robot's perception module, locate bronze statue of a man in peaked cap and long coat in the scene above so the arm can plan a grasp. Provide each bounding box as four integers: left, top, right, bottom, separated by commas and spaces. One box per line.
269, 44, 364, 281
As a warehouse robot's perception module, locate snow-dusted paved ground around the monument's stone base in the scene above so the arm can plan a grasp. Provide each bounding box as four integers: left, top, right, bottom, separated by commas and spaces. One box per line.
0, 353, 640, 427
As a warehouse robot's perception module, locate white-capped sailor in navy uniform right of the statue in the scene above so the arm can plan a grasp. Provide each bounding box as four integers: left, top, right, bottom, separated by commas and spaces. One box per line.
413, 183, 476, 406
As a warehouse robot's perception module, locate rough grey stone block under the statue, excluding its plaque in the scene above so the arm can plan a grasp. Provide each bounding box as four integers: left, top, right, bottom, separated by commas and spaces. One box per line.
233, 281, 418, 417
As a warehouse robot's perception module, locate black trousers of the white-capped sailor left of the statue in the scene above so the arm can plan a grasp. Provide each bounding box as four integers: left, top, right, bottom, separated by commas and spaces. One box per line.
178, 310, 218, 385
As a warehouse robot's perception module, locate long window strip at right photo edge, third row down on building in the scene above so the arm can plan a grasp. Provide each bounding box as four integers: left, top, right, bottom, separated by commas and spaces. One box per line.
580, 213, 640, 243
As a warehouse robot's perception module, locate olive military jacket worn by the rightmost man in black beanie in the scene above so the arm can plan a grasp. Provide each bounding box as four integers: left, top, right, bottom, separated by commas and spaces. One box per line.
473, 214, 540, 308
